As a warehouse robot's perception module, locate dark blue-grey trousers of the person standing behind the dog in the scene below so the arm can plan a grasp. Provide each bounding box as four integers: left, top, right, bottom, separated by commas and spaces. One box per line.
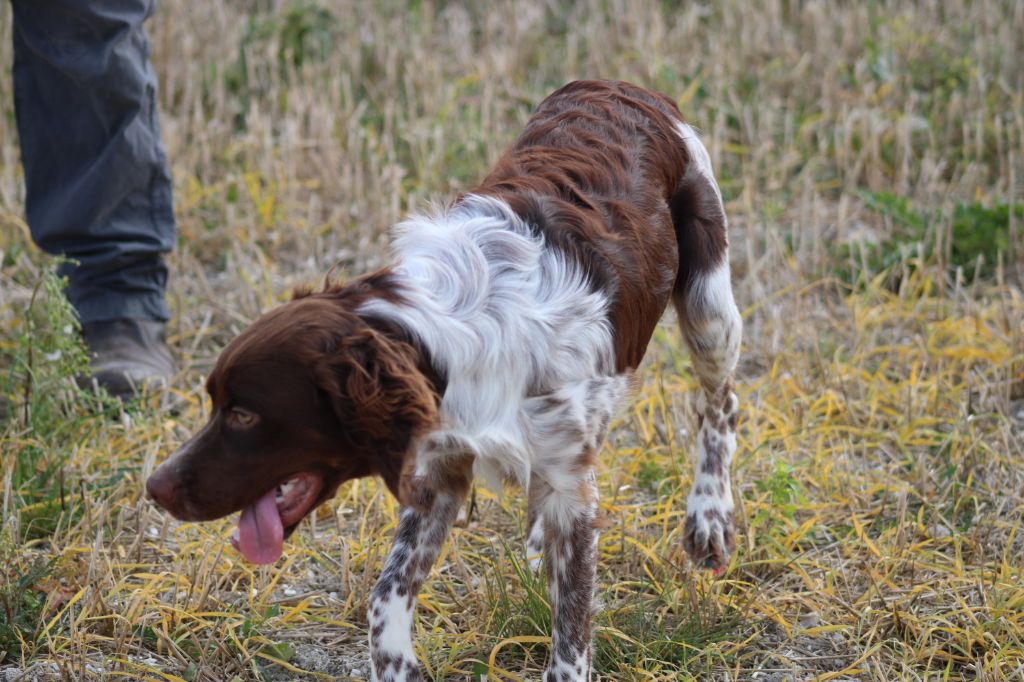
11, 0, 175, 323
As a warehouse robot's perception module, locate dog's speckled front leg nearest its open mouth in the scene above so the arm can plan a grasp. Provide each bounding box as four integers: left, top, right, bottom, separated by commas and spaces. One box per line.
368, 458, 472, 682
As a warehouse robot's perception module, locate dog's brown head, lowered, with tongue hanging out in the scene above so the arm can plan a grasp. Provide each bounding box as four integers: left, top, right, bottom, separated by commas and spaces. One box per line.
146, 294, 437, 563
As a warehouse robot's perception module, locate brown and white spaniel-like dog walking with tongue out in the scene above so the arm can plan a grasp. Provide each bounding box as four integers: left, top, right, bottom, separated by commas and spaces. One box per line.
146, 81, 741, 682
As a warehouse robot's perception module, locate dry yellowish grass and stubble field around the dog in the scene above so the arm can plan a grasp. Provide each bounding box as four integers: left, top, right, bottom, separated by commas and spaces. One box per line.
0, 0, 1024, 681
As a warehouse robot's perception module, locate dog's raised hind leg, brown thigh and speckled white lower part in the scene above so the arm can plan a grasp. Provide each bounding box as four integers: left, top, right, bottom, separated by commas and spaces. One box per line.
671, 124, 742, 570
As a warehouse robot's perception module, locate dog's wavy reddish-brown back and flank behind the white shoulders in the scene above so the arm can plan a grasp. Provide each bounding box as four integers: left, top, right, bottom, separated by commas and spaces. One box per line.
471, 81, 725, 372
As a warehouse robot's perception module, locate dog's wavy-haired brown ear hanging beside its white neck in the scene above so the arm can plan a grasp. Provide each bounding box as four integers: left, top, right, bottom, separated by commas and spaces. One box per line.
316, 328, 437, 504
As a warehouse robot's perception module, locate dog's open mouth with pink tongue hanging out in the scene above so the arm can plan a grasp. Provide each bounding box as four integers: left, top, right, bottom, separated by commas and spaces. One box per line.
231, 471, 324, 563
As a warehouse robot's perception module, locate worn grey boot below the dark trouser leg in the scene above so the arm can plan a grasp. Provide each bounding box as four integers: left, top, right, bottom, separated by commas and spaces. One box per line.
82, 319, 174, 399
